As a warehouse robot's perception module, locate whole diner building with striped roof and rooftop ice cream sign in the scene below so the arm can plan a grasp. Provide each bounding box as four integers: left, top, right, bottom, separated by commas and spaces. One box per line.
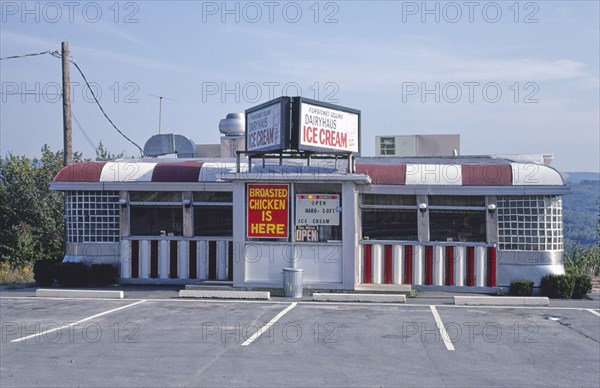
51, 98, 569, 291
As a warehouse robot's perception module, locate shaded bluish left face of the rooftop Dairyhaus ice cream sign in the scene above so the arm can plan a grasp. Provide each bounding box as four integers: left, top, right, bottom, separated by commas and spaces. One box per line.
246, 102, 282, 151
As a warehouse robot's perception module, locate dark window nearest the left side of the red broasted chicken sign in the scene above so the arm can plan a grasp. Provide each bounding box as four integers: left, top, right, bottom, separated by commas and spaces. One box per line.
193, 191, 233, 237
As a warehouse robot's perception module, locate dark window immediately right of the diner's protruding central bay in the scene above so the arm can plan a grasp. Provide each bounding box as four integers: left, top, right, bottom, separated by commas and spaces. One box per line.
361, 194, 418, 241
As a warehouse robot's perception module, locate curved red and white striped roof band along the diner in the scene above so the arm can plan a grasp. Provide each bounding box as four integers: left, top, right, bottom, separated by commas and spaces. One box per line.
54, 158, 565, 186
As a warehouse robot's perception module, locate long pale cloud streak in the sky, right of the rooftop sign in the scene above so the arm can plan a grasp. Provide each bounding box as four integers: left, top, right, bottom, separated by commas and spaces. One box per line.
253, 42, 589, 90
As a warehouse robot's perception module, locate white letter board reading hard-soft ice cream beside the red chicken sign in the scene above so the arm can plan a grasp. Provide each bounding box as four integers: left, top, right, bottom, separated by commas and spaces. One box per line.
296, 194, 341, 226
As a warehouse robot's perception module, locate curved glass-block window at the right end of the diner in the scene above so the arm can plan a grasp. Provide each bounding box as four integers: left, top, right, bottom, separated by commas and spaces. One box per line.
497, 195, 563, 251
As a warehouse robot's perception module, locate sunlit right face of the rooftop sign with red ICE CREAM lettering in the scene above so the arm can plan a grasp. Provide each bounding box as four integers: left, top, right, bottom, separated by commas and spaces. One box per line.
299, 102, 359, 152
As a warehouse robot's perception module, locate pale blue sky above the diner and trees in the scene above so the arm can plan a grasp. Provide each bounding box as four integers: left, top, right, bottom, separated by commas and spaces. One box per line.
0, 1, 600, 172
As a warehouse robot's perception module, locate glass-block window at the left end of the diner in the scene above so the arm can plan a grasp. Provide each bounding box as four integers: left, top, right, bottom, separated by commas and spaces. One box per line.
65, 191, 119, 243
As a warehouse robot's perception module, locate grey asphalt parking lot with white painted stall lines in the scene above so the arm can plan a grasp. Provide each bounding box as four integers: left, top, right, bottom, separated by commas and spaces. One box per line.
0, 292, 600, 387
